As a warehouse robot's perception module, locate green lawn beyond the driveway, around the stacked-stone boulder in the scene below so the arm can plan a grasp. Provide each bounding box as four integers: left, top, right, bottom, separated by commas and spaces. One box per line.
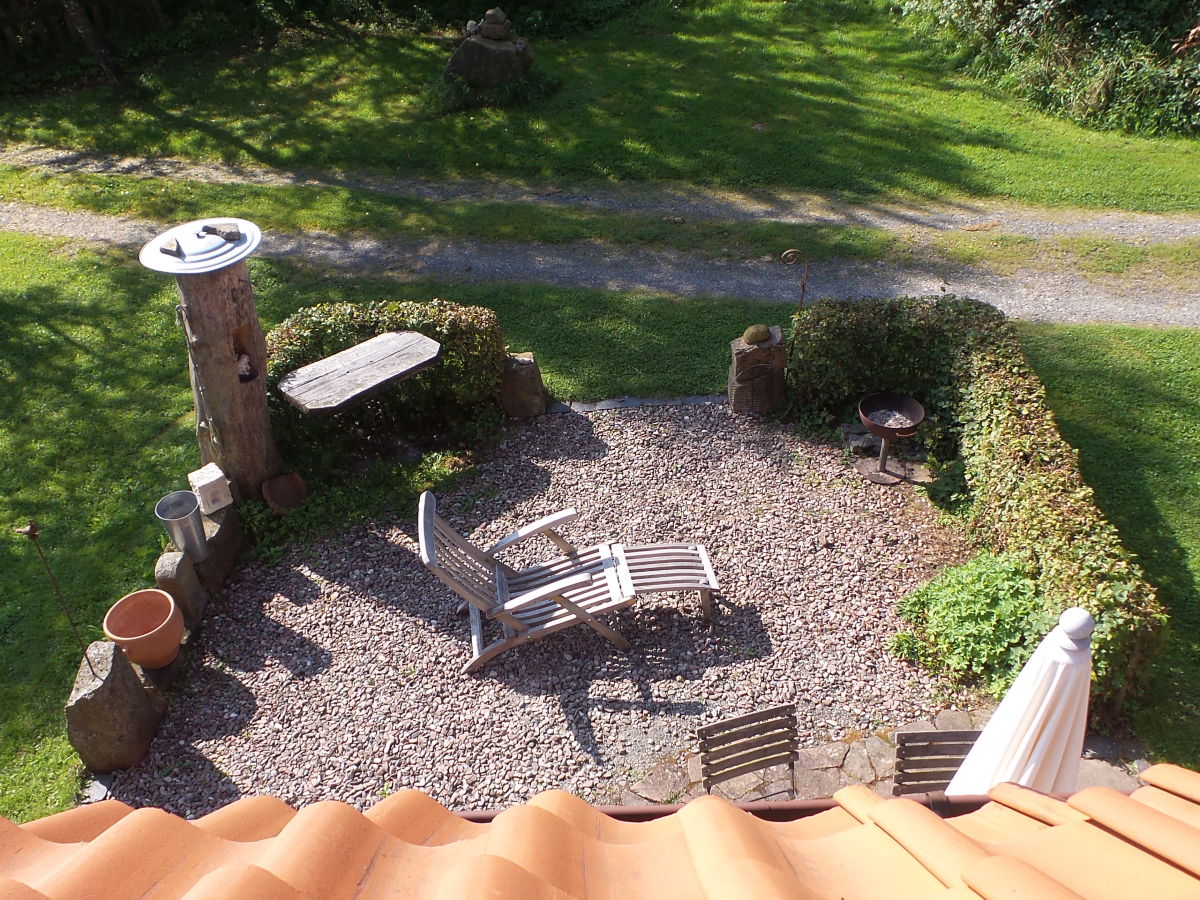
0, 0, 1200, 210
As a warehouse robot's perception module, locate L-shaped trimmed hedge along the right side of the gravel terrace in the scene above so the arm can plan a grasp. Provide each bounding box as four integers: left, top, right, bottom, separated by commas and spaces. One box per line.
788, 296, 1166, 714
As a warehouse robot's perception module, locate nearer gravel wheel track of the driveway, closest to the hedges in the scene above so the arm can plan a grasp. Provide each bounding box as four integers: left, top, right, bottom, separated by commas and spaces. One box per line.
0, 203, 1200, 328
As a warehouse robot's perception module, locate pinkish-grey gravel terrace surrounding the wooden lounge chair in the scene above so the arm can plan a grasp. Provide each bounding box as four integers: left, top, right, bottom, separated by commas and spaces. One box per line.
113, 404, 966, 816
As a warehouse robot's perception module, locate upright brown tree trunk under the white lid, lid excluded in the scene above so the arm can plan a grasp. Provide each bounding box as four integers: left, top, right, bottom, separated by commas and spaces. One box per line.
175, 259, 281, 500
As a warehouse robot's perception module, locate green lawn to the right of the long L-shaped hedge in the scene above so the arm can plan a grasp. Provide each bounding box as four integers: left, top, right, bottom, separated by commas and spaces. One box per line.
1021, 325, 1200, 767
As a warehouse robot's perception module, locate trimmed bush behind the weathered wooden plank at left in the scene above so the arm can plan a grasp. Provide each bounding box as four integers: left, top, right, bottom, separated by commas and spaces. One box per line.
266, 299, 505, 466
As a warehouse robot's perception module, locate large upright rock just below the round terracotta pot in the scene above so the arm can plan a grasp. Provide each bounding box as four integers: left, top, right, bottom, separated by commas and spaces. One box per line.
66, 641, 167, 773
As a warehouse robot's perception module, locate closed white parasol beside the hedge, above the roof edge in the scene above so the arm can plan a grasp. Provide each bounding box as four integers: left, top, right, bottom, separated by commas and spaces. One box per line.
946, 606, 1096, 796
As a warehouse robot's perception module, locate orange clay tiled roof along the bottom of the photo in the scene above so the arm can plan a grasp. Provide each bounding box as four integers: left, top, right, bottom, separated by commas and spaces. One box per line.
0, 766, 1200, 900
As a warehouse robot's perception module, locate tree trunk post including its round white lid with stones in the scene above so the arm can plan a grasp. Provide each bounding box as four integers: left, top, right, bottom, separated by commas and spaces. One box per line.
140, 220, 281, 500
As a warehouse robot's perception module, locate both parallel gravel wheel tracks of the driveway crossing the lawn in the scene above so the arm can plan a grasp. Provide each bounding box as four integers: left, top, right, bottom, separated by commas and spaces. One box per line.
0, 148, 1200, 326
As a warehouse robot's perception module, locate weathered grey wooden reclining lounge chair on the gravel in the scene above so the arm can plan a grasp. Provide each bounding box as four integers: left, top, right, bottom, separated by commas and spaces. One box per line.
418, 491, 719, 672
